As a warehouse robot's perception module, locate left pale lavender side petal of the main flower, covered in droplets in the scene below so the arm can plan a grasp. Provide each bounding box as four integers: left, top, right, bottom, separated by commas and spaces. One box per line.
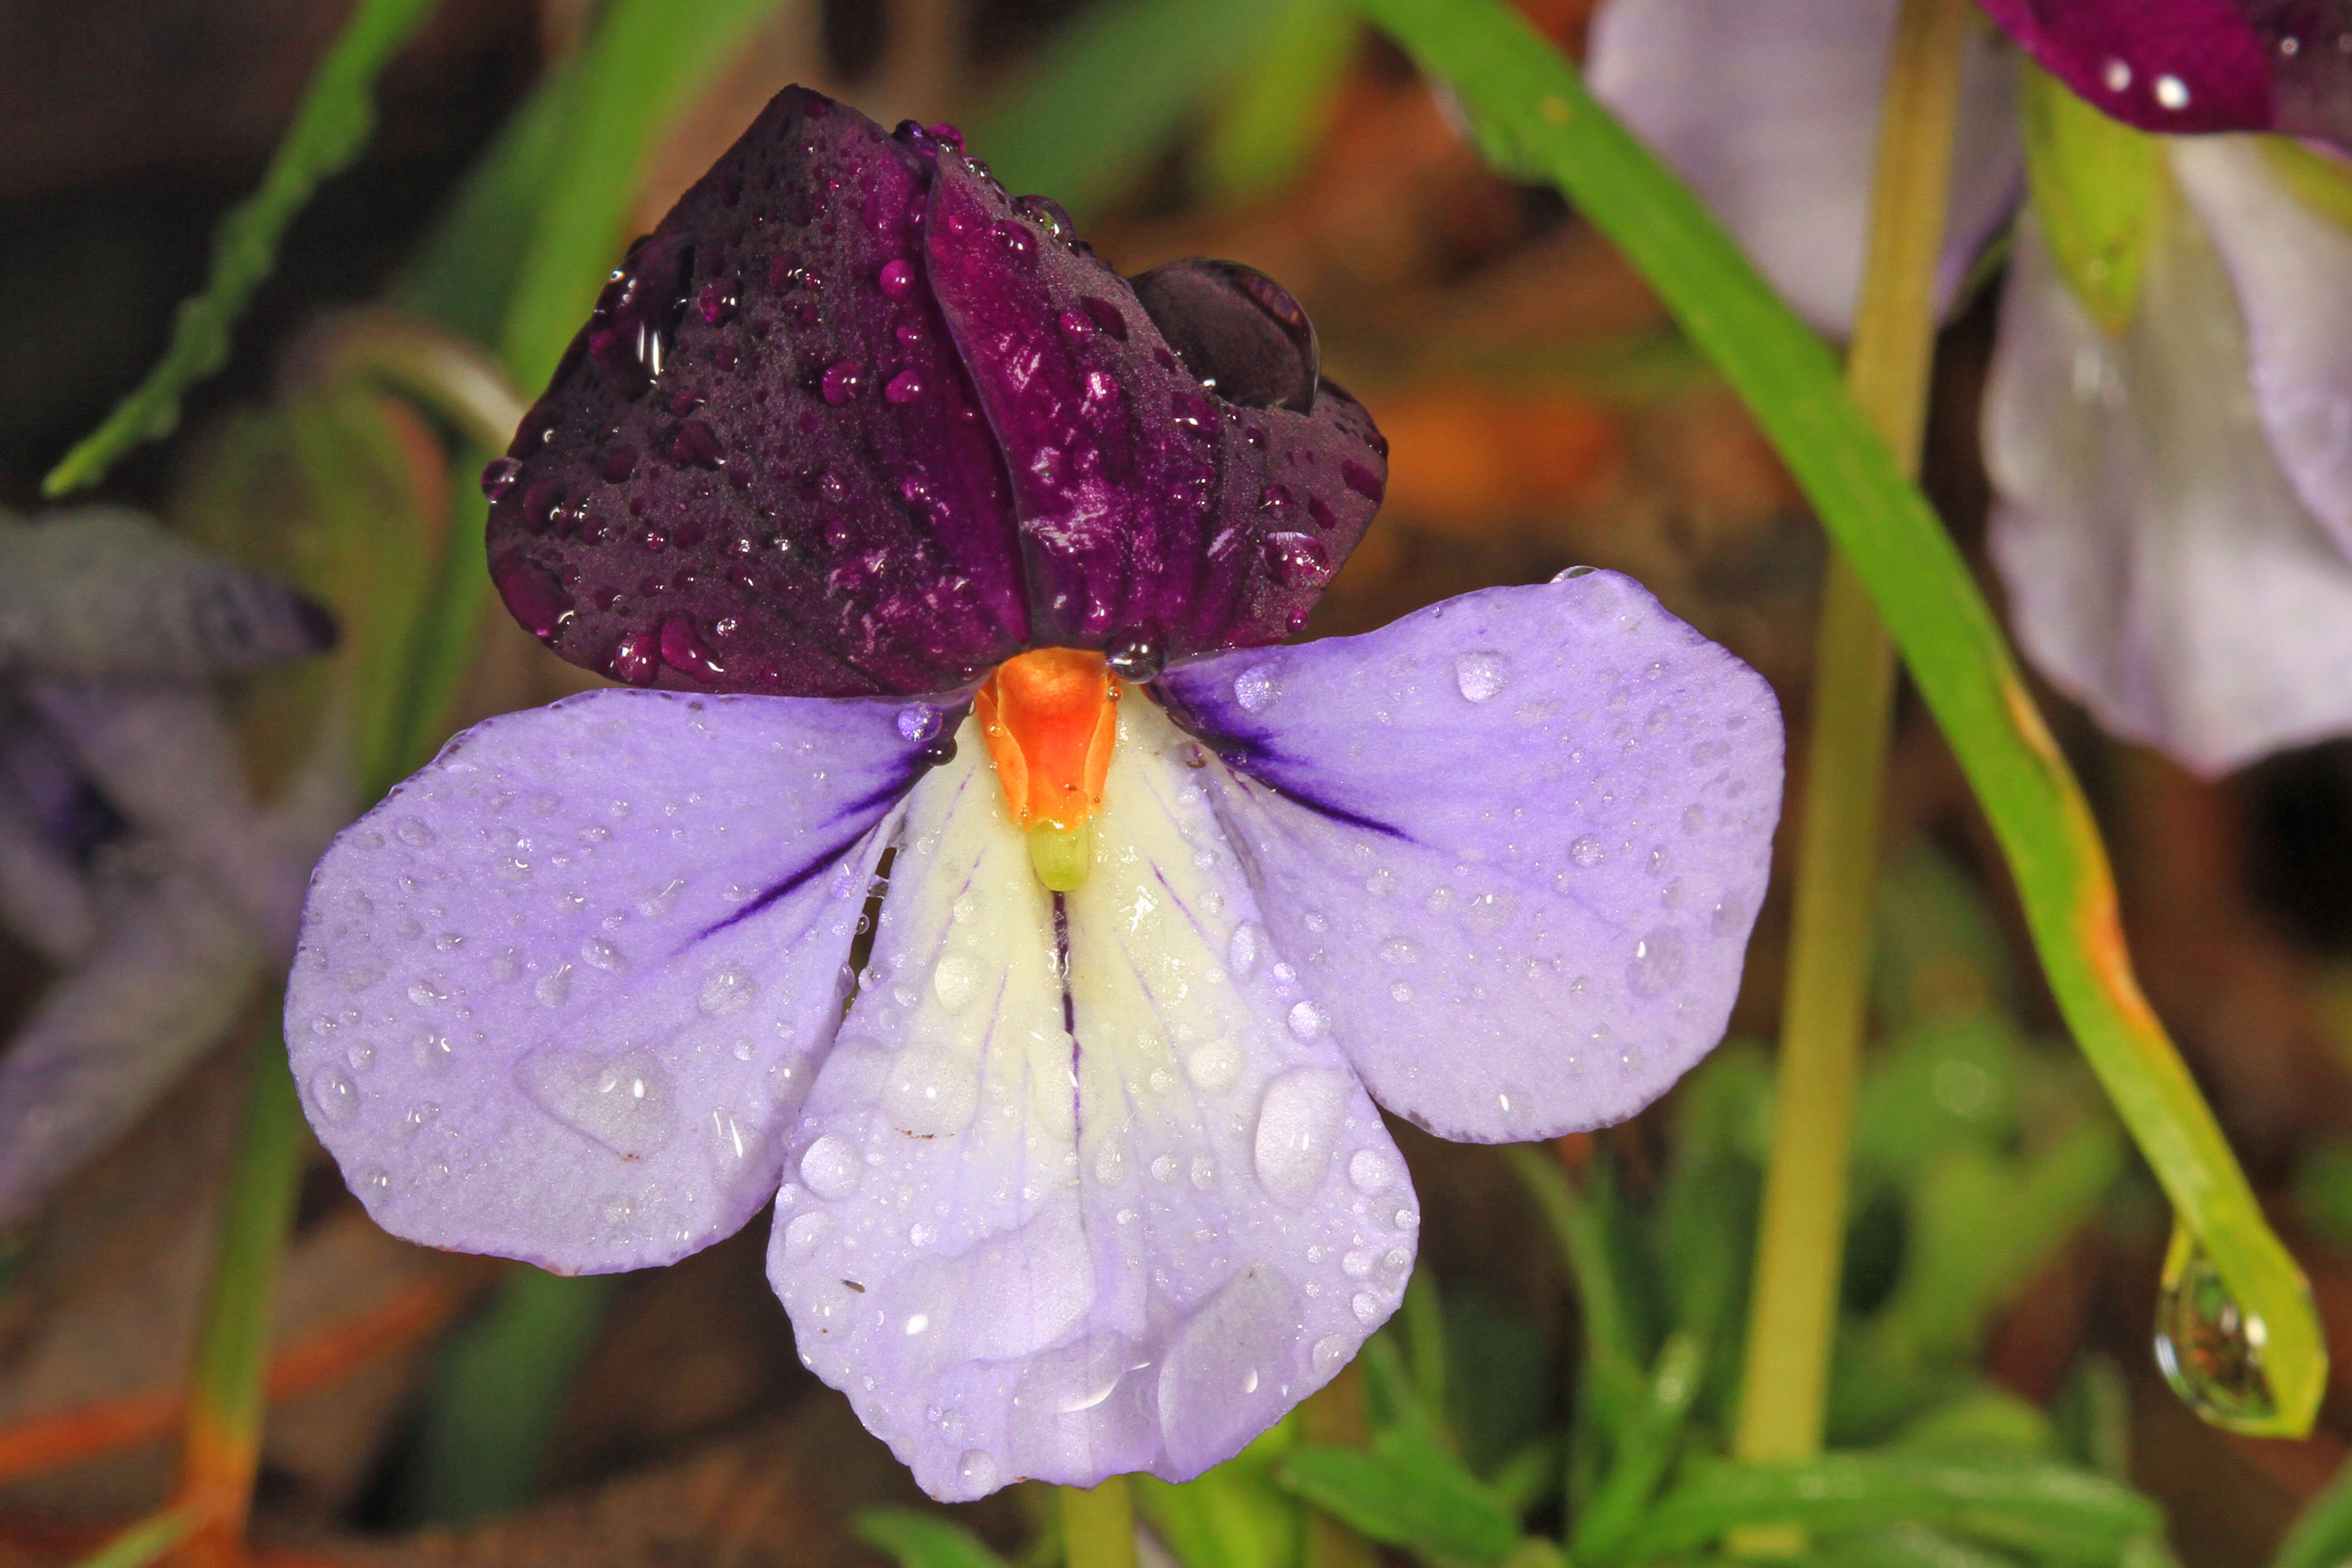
287, 691, 941, 1272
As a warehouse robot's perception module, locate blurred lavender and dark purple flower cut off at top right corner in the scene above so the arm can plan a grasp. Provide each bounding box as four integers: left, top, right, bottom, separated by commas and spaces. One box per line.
1590, 0, 2352, 774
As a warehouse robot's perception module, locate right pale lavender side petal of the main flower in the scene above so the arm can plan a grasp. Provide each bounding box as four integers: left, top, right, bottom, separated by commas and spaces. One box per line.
1160, 571, 1780, 1142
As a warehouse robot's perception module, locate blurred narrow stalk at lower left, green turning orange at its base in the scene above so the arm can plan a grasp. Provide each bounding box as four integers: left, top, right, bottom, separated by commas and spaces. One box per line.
176, 1029, 304, 1563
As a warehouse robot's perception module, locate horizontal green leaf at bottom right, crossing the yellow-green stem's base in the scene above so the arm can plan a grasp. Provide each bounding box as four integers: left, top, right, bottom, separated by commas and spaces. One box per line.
1625, 1453, 2164, 1563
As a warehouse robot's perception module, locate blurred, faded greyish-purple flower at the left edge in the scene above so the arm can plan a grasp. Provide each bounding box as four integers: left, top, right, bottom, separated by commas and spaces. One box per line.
0, 508, 334, 1227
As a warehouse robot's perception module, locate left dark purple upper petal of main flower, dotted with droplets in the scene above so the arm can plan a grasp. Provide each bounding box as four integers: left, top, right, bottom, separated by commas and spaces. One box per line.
485, 87, 1028, 696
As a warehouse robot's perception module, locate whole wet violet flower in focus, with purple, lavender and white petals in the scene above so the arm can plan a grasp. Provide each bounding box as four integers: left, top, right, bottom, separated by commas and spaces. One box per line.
287, 89, 1780, 1498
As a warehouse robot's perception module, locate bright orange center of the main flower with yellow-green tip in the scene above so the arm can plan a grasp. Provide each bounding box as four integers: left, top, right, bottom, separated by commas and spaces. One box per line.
971, 649, 1120, 893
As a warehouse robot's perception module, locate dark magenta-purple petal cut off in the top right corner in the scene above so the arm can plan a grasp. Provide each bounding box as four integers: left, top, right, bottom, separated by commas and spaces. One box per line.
1980, 0, 2352, 148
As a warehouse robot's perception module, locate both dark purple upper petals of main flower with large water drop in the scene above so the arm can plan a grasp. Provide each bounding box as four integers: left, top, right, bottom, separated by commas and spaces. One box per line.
485, 87, 1385, 696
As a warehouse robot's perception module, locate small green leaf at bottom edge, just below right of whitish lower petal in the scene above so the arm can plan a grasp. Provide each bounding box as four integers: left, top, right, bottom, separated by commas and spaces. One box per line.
1275, 1434, 1519, 1563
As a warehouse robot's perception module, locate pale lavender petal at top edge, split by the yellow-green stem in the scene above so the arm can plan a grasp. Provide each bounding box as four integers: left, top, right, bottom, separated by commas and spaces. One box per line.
1585, 0, 2025, 334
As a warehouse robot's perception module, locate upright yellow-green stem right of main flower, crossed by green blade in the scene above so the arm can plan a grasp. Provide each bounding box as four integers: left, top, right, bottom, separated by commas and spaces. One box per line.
1734, 0, 1971, 1504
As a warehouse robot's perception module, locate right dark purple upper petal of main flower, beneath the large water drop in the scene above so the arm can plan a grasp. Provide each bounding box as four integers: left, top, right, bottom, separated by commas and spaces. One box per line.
926, 151, 1388, 658
